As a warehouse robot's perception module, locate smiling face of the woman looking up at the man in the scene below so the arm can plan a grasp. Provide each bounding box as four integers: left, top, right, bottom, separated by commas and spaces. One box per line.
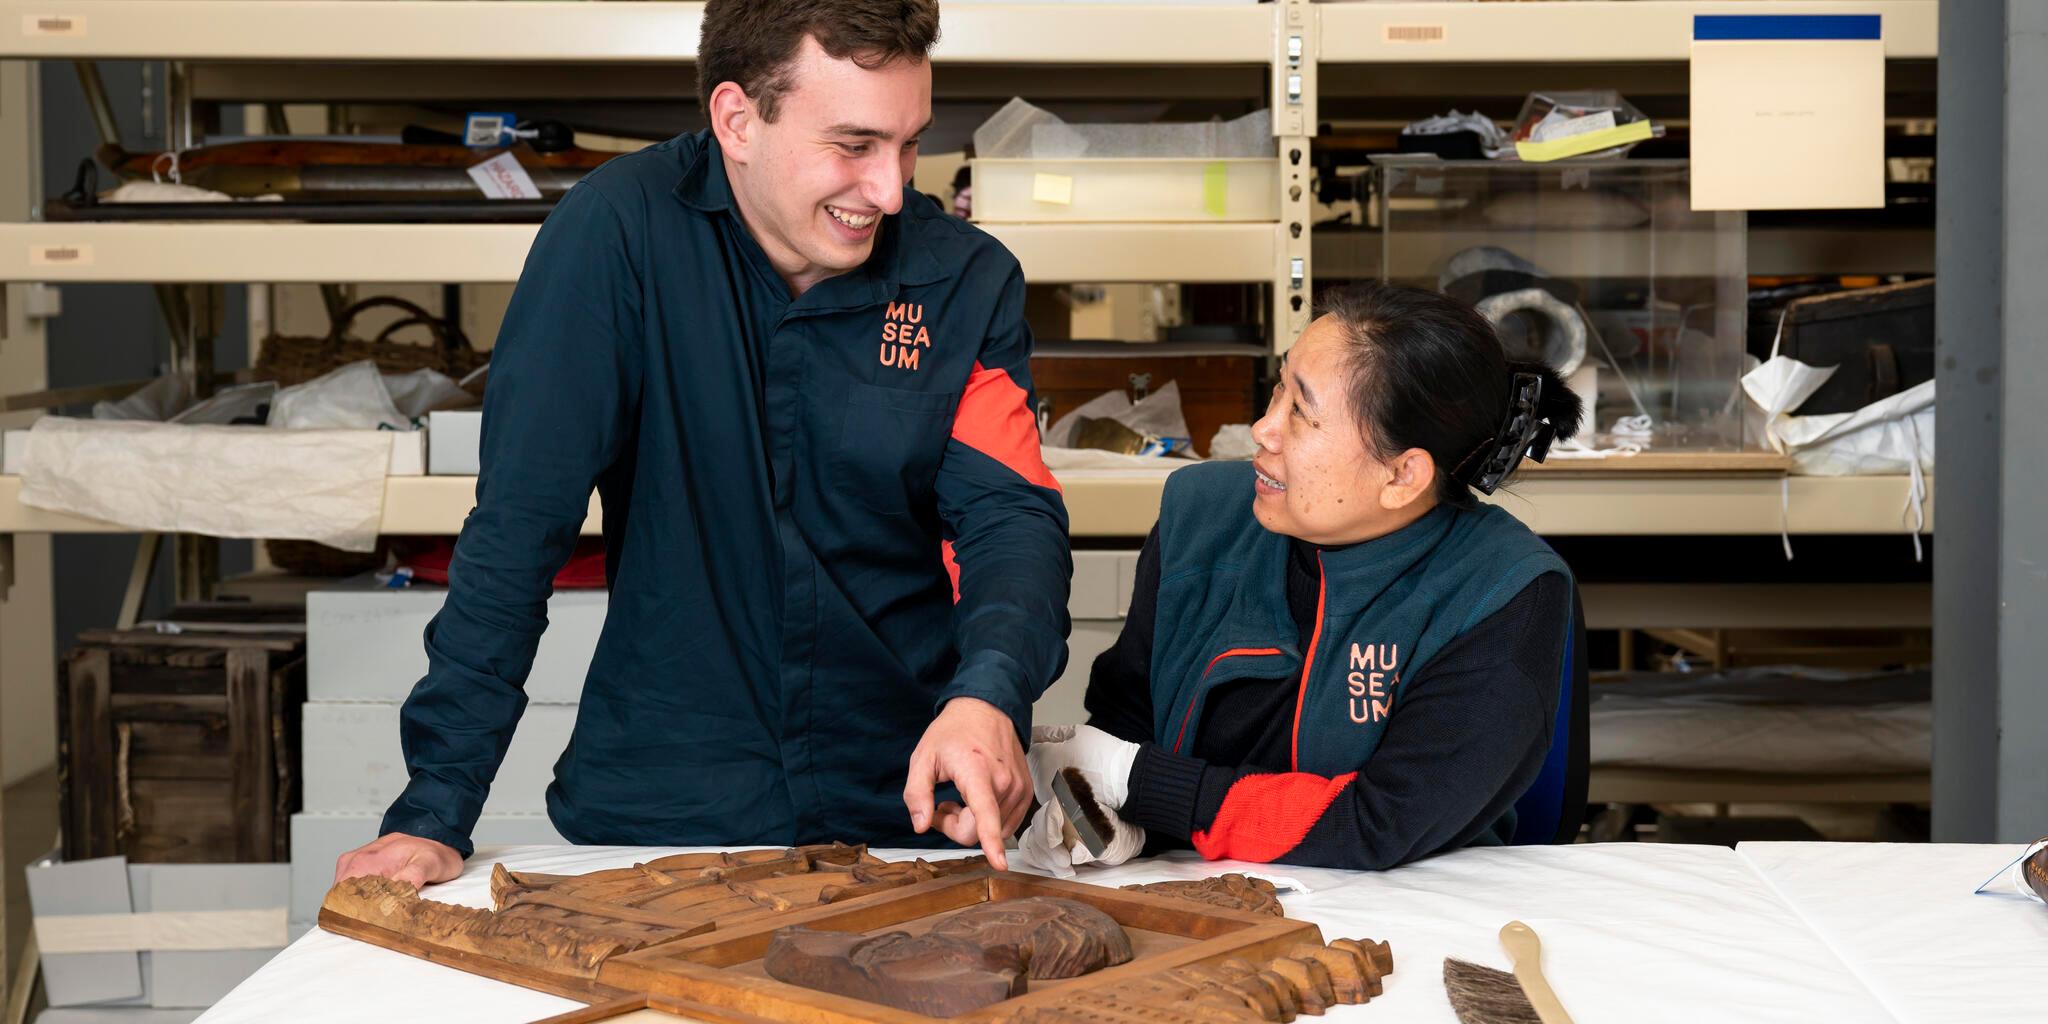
1251, 315, 1436, 545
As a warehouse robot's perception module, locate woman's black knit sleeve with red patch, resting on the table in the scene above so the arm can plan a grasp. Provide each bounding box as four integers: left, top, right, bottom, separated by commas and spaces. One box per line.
1124, 573, 1571, 868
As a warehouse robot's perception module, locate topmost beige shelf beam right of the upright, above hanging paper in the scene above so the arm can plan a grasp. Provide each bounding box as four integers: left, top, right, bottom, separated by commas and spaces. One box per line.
1317, 0, 1937, 63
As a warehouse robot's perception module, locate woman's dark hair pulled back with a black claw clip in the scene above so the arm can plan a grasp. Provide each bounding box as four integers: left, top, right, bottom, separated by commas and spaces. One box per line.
1319, 285, 1581, 506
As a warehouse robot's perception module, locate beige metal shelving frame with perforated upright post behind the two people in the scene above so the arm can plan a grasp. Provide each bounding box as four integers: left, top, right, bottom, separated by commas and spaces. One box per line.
0, 0, 1937, 537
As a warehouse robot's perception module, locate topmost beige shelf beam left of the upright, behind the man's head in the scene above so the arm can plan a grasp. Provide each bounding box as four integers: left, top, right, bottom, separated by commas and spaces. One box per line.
0, 0, 1274, 66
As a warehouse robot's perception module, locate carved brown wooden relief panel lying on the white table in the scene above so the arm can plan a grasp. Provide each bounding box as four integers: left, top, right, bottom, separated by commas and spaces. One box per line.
319, 844, 1393, 1024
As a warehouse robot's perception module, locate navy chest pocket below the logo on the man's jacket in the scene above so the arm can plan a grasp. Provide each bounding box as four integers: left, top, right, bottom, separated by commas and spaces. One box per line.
831, 381, 961, 516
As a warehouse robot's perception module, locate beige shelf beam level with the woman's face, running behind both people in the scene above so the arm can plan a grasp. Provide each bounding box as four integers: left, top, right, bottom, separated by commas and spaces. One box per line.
0, 471, 1933, 537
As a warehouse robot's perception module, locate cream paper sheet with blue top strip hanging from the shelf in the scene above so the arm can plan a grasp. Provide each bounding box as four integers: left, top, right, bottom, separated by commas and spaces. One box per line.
1692, 14, 1884, 209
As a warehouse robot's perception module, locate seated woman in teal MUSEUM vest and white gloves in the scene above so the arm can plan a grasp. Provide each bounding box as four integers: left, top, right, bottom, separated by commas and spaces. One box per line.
1020, 287, 1579, 874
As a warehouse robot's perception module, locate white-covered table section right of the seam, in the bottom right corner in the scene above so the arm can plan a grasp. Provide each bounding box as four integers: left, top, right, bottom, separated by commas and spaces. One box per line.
1737, 842, 2048, 1024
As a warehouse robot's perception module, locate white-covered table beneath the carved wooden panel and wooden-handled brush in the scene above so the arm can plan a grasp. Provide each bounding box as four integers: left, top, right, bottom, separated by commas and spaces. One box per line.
201, 844, 1916, 1024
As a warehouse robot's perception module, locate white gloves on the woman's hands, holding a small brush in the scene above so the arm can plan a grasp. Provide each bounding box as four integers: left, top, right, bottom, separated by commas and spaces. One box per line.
1018, 725, 1145, 879
